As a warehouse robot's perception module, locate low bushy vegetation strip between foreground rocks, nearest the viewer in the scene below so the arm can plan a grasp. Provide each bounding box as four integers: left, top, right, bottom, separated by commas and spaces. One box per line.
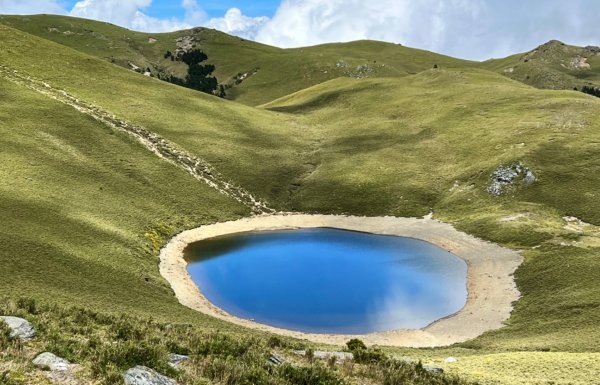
0, 299, 476, 385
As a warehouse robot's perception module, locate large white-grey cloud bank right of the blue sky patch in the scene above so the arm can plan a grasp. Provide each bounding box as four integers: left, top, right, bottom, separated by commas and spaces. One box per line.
256, 0, 600, 59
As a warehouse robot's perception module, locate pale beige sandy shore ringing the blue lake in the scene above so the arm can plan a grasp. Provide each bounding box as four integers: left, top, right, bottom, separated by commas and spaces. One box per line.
160, 214, 522, 347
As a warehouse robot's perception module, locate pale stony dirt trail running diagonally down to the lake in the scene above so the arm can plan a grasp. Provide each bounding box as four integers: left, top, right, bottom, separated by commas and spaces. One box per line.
0, 65, 275, 214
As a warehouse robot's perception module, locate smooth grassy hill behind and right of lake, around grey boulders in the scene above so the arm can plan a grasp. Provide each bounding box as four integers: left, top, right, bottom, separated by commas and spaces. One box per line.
264, 70, 600, 351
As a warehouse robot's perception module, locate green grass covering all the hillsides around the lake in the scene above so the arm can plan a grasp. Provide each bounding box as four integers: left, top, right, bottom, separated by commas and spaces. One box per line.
0, 16, 600, 384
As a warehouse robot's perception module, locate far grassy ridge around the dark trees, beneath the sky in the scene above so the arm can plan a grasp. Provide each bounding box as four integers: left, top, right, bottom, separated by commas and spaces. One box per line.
0, 15, 474, 105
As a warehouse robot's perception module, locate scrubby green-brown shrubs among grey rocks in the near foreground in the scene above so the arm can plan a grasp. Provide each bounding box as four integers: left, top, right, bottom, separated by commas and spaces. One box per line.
0, 299, 482, 385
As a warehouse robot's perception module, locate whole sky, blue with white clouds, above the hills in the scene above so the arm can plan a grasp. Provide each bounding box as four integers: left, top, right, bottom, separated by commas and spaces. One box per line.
0, 0, 600, 60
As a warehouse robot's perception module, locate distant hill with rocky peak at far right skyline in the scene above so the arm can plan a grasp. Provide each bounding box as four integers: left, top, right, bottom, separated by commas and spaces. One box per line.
481, 40, 600, 90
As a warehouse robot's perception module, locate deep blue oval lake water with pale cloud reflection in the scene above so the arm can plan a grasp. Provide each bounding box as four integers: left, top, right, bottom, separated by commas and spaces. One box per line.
185, 228, 467, 334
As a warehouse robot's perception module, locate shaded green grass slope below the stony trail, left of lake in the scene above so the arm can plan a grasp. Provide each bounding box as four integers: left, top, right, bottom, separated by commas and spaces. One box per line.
0, 74, 248, 316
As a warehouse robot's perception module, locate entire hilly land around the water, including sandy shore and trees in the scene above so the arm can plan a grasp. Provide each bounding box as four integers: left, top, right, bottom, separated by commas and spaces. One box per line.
0, 11, 600, 385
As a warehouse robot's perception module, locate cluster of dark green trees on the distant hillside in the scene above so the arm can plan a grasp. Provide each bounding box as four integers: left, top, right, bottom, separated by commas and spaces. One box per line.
159, 49, 221, 96
